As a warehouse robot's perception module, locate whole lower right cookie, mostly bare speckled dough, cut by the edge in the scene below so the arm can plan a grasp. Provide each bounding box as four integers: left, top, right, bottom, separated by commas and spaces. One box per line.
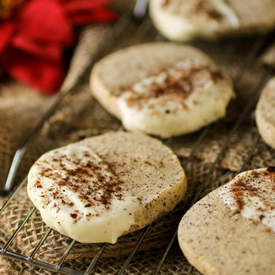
178, 168, 275, 275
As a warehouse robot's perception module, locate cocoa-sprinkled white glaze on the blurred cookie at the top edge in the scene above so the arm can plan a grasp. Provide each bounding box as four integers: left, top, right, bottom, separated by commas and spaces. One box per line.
150, 0, 241, 41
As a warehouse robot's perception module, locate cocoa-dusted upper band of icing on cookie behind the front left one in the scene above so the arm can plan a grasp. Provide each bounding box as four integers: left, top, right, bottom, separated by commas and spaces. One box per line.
120, 60, 225, 113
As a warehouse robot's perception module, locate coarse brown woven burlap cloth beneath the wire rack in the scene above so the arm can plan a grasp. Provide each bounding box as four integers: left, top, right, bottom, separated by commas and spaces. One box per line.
0, 12, 275, 275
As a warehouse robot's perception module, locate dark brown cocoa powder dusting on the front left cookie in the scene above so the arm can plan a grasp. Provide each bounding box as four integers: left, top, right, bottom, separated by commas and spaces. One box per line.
35, 148, 123, 220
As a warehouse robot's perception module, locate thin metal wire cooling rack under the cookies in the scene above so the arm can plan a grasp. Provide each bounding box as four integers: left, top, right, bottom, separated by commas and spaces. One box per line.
0, 1, 275, 275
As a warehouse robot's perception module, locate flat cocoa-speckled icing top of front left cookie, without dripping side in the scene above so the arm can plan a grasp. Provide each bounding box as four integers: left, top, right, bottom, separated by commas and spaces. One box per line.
30, 144, 125, 223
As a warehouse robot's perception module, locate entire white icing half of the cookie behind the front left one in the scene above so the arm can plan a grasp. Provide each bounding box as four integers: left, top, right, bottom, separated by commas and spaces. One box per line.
118, 59, 234, 137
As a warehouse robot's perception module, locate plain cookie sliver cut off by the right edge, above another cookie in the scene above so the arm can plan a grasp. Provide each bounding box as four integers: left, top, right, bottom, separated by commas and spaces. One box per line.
256, 77, 275, 149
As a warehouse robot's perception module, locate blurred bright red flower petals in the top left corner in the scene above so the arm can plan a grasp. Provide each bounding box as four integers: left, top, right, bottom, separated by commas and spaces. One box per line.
0, 0, 116, 93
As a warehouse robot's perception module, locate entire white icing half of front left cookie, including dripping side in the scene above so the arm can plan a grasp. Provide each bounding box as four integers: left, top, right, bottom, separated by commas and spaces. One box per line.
28, 144, 139, 243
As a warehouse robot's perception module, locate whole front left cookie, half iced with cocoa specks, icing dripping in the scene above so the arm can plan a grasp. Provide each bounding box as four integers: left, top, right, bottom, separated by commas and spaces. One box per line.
27, 132, 186, 243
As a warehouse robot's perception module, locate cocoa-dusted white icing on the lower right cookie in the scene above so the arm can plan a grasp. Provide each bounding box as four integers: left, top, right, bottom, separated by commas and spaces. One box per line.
219, 169, 275, 232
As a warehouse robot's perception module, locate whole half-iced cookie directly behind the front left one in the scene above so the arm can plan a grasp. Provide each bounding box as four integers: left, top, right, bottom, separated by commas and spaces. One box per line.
91, 42, 234, 138
